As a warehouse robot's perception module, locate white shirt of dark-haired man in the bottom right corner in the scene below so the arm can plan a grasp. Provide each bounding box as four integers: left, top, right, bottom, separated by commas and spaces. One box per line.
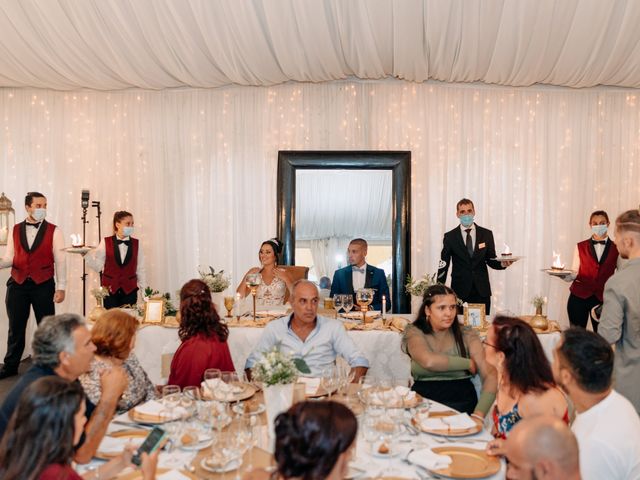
571, 390, 640, 480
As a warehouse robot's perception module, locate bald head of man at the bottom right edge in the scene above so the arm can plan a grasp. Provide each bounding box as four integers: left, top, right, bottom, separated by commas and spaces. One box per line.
505, 416, 580, 480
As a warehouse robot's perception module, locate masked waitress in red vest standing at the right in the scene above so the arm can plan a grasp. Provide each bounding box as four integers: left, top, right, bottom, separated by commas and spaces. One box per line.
565, 210, 618, 332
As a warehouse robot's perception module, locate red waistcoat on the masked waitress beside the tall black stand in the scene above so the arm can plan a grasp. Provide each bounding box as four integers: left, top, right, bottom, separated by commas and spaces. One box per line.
102, 235, 138, 294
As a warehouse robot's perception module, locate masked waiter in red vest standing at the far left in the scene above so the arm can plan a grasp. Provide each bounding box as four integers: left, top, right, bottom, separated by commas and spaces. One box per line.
0, 192, 67, 379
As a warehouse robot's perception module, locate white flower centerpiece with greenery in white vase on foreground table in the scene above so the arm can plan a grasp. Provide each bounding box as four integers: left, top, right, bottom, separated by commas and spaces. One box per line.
251, 345, 311, 438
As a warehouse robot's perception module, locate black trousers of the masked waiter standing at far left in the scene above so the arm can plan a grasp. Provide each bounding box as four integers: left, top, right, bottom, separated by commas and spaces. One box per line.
4, 278, 56, 371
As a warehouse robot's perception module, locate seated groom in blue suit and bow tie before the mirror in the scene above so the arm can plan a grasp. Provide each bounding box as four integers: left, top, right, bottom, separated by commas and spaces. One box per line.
330, 238, 391, 311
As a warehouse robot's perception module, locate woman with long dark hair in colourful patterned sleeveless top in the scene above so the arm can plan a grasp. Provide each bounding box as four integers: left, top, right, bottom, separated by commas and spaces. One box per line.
484, 316, 569, 454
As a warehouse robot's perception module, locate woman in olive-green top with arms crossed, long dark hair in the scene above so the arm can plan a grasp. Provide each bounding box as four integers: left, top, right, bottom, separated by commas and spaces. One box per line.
403, 285, 497, 419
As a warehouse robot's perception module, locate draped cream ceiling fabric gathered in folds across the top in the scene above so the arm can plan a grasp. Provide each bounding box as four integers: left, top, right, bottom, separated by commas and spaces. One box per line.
0, 0, 640, 90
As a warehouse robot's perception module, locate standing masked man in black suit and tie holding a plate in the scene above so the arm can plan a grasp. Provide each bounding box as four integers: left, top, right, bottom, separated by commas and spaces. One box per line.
438, 198, 513, 315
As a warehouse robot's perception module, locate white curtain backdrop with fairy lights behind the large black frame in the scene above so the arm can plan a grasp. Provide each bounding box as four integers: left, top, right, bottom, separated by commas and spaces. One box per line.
0, 80, 640, 322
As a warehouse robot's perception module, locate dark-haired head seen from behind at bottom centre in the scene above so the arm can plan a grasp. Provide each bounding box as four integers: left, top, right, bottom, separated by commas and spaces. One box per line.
245, 401, 358, 480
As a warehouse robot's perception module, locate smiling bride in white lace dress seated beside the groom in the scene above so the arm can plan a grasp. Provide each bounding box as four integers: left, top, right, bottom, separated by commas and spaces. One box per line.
236, 238, 292, 306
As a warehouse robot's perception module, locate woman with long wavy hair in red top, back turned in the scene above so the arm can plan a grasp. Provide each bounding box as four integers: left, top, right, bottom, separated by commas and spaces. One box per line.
169, 280, 236, 388
